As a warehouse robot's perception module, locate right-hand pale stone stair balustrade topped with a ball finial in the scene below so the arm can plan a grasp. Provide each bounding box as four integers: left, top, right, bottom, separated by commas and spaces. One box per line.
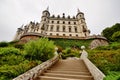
80, 47, 105, 80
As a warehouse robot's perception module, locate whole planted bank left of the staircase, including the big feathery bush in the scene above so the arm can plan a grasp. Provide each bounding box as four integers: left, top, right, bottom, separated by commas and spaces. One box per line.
0, 38, 55, 80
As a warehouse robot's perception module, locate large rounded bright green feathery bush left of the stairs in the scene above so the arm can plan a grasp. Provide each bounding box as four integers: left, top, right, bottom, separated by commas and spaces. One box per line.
24, 38, 55, 61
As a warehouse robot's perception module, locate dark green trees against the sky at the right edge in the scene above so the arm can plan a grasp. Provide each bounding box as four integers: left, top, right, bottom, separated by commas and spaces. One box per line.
102, 23, 120, 41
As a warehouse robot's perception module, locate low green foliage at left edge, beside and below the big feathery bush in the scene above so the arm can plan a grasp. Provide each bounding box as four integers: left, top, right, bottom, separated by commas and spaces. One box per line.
0, 47, 41, 80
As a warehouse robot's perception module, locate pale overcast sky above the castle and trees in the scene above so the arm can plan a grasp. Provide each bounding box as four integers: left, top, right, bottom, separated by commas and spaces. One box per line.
0, 0, 120, 41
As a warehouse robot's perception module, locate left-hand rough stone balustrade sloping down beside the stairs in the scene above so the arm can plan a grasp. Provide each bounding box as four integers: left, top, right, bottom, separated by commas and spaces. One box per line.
13, 55, 59, 80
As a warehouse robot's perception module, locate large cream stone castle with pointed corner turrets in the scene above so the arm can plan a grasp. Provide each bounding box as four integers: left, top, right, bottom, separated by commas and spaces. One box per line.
14, 8, 90, 41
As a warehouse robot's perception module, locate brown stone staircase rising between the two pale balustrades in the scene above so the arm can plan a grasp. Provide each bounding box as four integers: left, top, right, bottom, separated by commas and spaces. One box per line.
35, 58, 94, 80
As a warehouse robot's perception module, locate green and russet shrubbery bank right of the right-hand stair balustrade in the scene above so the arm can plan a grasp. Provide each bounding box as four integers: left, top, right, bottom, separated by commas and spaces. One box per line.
88, 42, 120, 80
